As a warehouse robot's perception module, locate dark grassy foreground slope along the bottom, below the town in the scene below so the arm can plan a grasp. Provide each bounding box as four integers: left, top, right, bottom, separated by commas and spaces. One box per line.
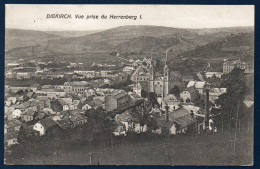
6, 133, 253, 165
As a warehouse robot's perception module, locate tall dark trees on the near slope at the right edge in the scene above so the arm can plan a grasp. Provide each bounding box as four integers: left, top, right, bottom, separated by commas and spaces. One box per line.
213, 69, 253, 132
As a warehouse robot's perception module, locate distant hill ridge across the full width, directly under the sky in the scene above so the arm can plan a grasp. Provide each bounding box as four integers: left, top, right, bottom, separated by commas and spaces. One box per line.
6, 25, 254, 59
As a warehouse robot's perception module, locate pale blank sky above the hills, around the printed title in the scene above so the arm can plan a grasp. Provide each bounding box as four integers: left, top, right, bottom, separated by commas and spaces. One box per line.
6, 4, 254, 31
